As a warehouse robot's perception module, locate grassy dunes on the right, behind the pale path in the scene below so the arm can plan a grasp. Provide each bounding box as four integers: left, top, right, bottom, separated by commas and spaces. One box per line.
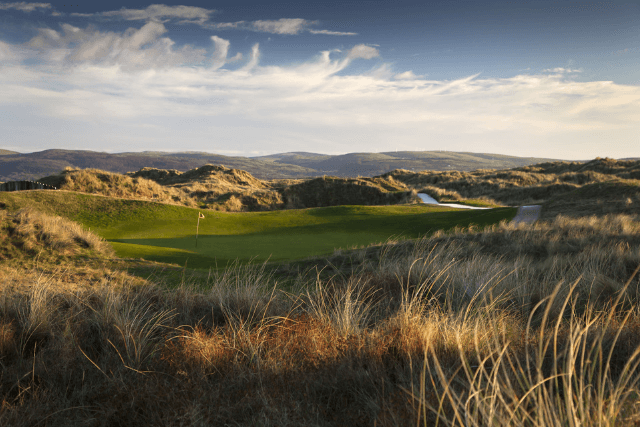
382, 158, 640, 219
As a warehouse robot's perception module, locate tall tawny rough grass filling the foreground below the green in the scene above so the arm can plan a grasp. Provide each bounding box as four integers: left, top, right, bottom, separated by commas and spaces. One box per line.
0, 207, 640, 426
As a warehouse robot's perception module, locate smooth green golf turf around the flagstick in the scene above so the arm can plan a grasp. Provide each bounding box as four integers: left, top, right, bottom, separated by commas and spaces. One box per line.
0, 190, 516, 269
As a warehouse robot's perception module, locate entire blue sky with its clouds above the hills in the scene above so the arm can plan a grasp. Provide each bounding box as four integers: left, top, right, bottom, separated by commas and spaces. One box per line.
0, 0, 640, 160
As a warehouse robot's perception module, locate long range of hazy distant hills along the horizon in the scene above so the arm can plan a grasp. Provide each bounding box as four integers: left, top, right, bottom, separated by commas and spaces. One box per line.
0, 149, 572, 182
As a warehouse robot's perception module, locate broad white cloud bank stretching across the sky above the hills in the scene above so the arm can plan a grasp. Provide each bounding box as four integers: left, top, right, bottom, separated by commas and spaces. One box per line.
0, 28, 640, 158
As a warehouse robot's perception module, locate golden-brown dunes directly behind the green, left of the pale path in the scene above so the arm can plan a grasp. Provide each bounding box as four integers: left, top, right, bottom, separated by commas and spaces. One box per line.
40, 165, 416, 211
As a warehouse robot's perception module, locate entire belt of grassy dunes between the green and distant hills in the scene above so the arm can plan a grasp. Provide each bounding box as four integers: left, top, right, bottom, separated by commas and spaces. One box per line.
36, 158, 640, 219
